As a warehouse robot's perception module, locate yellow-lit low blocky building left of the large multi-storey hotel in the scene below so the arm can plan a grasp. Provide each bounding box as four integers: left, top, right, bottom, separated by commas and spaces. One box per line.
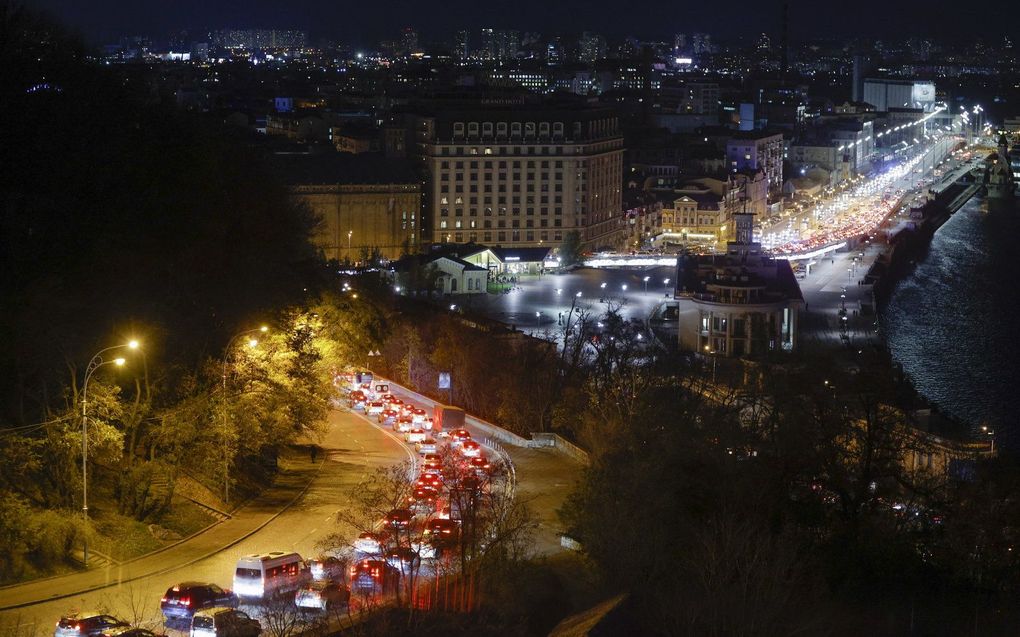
272, 153, 421, 261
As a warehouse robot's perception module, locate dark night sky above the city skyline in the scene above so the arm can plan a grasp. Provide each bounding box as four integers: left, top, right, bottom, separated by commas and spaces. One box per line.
27, 0, 1020, 46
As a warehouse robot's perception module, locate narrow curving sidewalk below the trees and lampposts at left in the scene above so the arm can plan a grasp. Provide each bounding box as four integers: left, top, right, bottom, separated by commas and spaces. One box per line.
0, 460, 322, 611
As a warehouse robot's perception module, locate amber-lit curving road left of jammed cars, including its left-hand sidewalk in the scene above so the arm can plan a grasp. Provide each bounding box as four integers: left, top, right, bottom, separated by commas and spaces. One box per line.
0, 411, 413, 637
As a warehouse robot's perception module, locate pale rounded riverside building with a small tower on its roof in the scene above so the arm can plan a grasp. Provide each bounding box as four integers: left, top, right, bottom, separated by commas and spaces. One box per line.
675, 213, 804, 357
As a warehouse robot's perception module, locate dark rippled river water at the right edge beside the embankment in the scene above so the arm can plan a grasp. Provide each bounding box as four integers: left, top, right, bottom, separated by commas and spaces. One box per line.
882, 197, 1020, 450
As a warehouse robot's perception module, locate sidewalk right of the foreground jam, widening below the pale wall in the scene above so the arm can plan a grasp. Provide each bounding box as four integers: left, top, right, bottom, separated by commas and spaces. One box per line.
375, 379, 584, 555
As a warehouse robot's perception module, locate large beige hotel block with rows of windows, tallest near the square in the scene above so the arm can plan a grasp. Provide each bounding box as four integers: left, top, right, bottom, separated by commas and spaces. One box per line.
388, 101, 623, 248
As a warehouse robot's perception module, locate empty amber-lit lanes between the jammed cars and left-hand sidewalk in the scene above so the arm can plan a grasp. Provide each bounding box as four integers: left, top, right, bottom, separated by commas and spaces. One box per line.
0, 412, 408, 637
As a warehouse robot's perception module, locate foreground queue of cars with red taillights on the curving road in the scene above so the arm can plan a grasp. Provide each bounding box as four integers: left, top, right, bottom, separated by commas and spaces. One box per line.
53, 372, 509, 637
